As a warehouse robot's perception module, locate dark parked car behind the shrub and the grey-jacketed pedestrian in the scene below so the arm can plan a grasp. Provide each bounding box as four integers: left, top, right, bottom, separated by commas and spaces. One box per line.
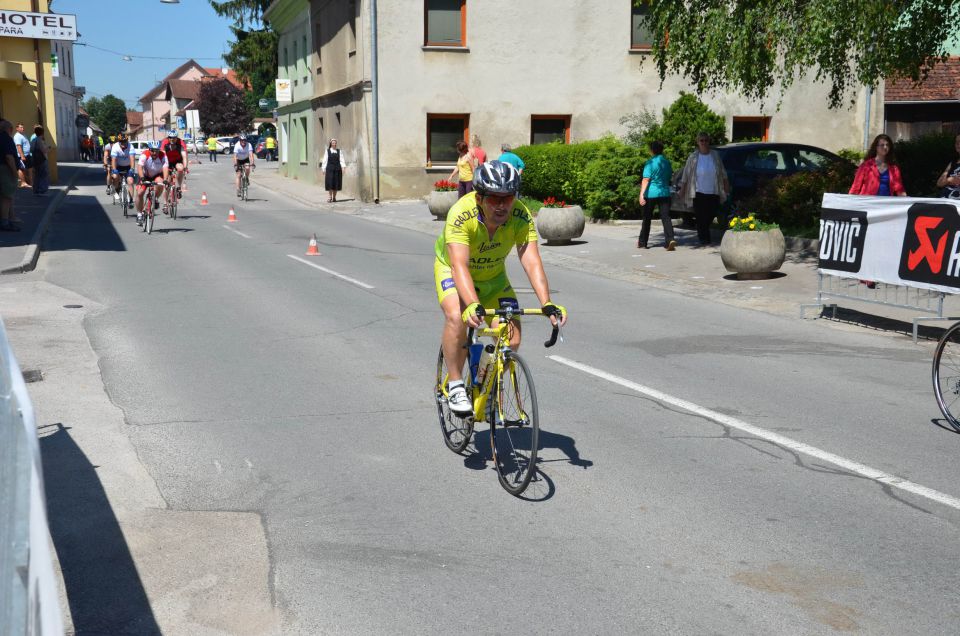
670, 142, 846, 216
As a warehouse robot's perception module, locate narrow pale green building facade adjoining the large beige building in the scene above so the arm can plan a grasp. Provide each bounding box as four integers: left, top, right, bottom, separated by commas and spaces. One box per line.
264, 0, 323, 182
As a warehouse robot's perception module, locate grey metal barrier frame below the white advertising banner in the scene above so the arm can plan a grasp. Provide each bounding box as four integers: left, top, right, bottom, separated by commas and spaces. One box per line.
800, 272, 958, 343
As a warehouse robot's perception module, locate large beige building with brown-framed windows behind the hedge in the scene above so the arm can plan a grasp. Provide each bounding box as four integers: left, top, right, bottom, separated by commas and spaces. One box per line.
267, 0, 883, 199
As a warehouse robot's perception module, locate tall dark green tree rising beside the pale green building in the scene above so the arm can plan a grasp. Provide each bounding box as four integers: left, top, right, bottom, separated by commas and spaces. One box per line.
210, 0, 278, 113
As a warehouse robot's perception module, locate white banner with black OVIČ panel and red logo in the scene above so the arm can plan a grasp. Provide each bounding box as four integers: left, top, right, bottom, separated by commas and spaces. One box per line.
819, 193, 960, 294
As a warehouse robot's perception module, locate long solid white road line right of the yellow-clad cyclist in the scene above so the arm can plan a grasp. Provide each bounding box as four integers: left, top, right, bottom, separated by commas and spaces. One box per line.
547, 356, 960, 510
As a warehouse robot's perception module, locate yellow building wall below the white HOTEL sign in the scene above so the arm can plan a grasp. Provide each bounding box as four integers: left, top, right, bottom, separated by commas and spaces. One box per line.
0, 0, 58, 183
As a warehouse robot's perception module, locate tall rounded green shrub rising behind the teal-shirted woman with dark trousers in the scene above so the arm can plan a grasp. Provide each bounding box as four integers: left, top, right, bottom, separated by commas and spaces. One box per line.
620, 91, 727, 170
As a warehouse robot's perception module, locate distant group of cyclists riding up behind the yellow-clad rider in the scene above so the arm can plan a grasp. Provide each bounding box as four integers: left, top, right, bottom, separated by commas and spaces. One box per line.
103, 130, 256, 225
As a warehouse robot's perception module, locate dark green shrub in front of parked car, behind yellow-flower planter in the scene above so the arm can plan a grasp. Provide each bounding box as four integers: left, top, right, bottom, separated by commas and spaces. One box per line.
737, 161, 857, 237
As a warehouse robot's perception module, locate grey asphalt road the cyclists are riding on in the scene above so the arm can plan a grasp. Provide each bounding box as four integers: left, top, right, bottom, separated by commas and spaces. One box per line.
11, 163, 960, 634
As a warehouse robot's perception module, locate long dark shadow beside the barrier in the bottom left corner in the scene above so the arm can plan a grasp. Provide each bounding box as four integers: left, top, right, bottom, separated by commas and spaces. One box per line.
39, 423, 160, 635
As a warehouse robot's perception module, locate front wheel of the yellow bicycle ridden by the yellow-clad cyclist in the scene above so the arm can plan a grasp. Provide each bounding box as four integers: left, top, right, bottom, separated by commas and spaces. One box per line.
490, 351, 540, 496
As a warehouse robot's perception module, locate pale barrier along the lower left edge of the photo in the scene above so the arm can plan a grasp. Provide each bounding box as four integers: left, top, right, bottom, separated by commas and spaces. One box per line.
0, 320, 63, 636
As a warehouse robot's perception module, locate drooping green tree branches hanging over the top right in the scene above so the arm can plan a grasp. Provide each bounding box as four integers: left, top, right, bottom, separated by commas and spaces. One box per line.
635, 0, 960, 108
